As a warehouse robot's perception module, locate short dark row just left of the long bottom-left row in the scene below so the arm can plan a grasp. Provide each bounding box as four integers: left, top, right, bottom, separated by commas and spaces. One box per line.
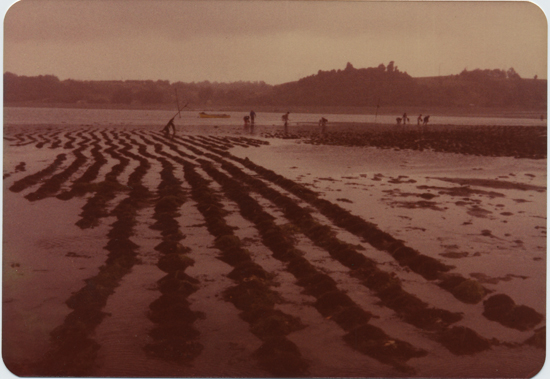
76, 132, 130, 229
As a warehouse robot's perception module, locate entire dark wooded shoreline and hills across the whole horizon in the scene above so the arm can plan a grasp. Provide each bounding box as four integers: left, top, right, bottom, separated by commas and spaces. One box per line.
4, 62, 547, 109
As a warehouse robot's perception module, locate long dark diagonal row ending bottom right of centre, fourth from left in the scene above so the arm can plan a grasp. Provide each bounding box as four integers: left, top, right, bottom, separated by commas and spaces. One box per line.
199, 160, 434, 373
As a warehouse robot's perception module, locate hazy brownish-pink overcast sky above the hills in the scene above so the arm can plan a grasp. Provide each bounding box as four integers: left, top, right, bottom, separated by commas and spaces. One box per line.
2, 0, 548, 84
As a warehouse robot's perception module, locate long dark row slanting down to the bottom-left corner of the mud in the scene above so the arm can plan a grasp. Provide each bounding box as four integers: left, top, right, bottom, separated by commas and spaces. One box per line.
36, 132, 153, 376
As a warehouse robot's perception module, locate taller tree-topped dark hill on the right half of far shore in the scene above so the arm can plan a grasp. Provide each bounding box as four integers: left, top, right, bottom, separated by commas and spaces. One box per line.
260, 62, 547, 109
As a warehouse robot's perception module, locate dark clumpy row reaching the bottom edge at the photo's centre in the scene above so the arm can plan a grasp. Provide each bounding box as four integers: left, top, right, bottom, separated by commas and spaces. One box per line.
138, 136, 308, 376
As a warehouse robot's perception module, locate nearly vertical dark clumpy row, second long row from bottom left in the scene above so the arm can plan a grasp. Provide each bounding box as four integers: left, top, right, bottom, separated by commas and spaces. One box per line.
140, 138, 203, 364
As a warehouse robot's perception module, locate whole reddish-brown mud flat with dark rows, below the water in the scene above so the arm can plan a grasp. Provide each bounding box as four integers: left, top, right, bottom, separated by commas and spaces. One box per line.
3, 124, 547, 377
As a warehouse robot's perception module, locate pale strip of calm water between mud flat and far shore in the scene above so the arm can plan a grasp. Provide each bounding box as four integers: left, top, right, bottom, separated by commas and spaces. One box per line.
4, 107, 546, 126
